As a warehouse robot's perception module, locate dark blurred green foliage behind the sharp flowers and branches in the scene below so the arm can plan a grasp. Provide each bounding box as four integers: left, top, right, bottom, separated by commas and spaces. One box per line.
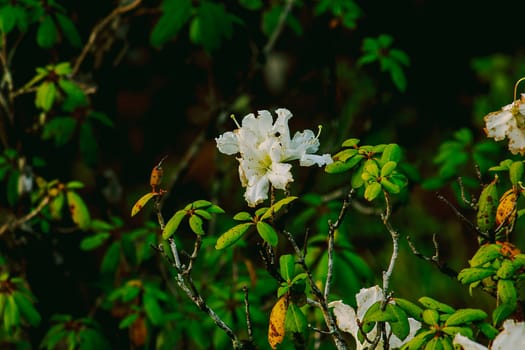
0, 0, 525, 349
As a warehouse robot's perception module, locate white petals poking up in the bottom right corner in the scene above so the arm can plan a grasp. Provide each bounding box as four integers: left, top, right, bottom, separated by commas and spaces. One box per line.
454, 319, 525, 350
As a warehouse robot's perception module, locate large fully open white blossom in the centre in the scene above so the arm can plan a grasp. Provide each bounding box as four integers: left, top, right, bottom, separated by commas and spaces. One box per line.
215, 108, 332, 207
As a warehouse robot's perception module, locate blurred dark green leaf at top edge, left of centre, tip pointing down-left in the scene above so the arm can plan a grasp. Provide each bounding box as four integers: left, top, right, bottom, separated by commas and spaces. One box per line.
150, 0, 193, 48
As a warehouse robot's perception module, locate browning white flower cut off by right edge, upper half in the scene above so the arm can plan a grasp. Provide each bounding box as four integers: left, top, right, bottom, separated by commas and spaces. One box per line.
484, 94, 525, 155
